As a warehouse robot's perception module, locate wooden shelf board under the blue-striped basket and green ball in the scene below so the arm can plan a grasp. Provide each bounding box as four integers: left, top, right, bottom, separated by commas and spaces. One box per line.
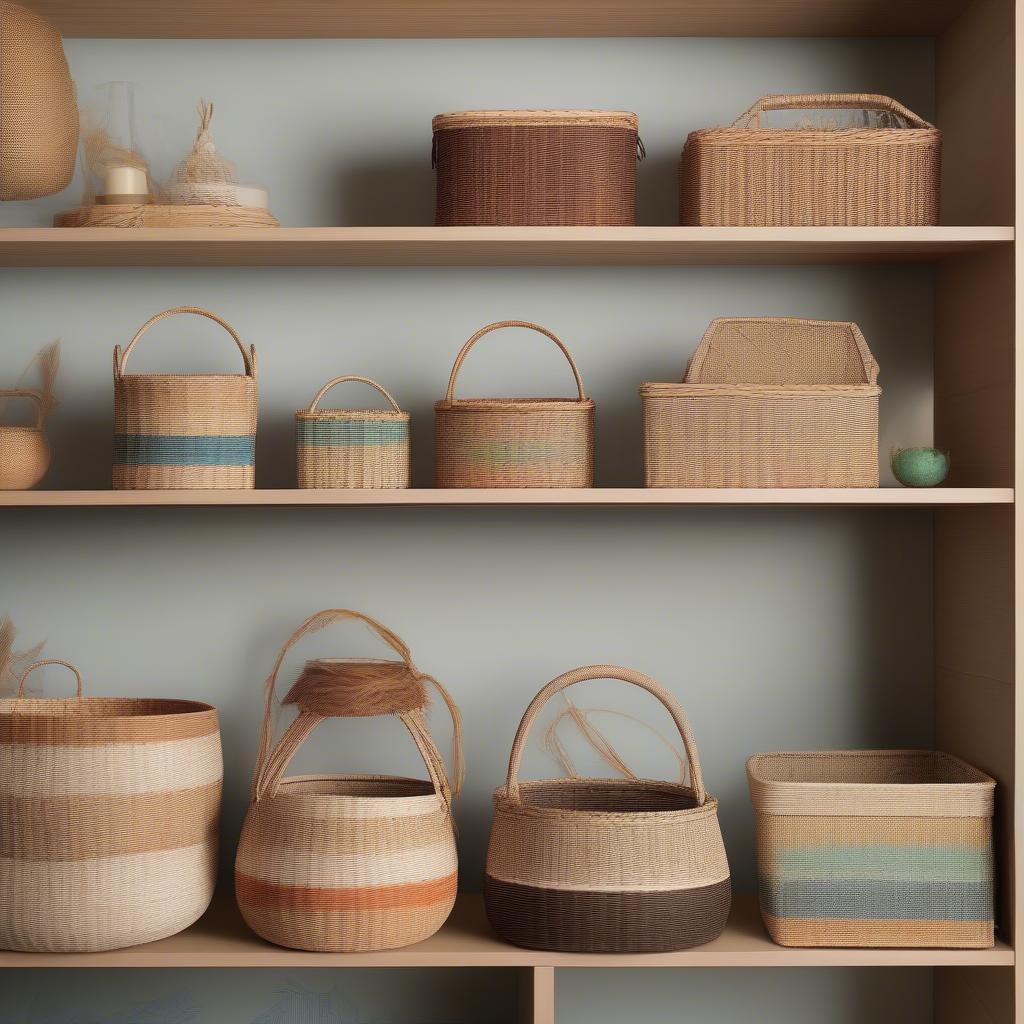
0, 487, 1014, 508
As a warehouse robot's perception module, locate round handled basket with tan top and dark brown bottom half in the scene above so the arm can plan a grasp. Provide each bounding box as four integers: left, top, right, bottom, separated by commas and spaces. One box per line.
483, 665, 731, 953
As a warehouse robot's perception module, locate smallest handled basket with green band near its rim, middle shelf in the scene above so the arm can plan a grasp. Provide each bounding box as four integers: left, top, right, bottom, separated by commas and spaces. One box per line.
295, 376, 409, 487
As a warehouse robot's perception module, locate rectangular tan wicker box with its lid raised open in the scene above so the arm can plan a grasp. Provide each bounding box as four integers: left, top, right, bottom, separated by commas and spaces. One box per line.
640, 317, 881, 487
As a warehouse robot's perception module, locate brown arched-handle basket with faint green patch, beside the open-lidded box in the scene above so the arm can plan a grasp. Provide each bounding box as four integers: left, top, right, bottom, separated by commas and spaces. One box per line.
434, 321, 594, 487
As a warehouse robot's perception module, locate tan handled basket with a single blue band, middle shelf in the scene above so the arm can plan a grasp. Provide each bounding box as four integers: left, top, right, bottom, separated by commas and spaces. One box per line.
114, 306, 257, 489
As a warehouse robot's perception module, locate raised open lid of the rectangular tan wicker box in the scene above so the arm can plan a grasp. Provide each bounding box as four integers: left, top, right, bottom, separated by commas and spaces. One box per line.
684, 316, 879, 385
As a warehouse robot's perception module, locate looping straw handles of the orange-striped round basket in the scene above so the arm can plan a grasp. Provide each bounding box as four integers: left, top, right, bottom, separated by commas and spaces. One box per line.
252, 608, 464, 808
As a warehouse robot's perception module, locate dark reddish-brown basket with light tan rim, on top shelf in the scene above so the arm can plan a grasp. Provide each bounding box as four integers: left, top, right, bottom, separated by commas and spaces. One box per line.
433, 111, 643, 226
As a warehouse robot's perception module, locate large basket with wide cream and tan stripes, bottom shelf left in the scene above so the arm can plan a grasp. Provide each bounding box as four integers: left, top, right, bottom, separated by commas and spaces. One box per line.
0, 660, 223, 952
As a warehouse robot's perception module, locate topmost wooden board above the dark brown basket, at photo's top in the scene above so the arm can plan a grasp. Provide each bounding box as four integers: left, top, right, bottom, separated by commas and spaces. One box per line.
22, 0, 968, 39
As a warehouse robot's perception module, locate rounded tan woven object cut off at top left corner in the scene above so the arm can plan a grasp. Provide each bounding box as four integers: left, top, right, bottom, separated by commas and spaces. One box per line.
0, 0, 78, 201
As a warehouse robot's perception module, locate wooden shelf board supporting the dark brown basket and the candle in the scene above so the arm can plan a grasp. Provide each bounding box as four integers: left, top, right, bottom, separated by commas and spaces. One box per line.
0, 227, 1014, 267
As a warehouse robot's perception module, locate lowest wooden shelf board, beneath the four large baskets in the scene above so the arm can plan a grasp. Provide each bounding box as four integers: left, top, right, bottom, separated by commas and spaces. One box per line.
0, 893, 1014, 968
